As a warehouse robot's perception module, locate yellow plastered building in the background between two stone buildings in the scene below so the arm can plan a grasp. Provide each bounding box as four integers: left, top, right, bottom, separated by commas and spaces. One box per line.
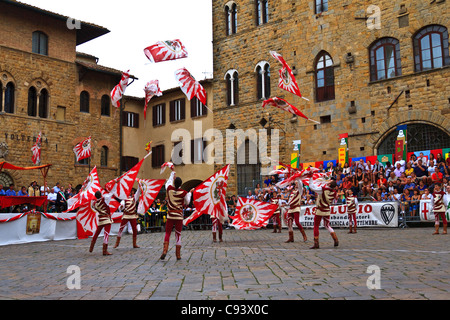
122, 79, 214, 190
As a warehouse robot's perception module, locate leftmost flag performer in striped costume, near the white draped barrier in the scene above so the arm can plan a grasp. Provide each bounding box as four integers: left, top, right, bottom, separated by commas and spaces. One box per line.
89, 191, 113, 256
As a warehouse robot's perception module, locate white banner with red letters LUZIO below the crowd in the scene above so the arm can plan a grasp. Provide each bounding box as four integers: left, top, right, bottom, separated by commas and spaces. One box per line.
286, 202, 398, 228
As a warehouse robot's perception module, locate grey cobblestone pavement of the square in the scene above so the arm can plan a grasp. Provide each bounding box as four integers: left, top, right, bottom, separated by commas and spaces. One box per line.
0, 227, 450, 301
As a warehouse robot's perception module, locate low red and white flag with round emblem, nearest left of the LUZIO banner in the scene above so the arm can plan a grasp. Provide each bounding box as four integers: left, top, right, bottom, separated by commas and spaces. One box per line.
230, 198, 278, 230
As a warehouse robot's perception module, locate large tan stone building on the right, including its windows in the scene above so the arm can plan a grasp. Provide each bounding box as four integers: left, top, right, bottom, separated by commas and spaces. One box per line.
213, 0, 450, 194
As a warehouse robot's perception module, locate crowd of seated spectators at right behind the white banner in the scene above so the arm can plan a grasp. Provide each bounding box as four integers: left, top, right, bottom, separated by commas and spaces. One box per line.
227, 153, 450, 215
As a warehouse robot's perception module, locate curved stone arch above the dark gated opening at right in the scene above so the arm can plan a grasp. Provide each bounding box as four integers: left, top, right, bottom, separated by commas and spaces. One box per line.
368, 110, 450, 154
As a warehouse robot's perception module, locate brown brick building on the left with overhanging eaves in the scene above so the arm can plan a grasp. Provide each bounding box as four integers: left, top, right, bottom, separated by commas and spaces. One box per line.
0, 0, 125, 189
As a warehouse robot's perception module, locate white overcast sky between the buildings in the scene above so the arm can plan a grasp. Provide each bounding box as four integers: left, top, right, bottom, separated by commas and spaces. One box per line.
19, 0, 212, 97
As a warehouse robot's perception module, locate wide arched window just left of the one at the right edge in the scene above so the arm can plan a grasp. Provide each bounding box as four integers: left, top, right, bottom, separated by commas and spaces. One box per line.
369, 38, 402, 81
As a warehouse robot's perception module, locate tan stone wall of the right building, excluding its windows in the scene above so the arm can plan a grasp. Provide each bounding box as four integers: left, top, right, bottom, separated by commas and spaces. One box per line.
213, 0, 450, 193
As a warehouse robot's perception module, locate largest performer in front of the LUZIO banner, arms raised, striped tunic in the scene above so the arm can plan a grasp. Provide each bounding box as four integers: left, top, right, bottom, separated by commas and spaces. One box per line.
309, 178, 339, 249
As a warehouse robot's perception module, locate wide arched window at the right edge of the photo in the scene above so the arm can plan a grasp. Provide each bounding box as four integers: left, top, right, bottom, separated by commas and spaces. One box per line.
414, 25, 450, 71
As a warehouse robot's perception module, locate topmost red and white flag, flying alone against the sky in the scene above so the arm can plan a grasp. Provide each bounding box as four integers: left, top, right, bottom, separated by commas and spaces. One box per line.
144, 39, 188, 63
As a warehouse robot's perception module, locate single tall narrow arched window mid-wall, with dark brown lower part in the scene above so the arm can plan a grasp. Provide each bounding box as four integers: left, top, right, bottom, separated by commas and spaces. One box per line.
315, 52, 335, 102
